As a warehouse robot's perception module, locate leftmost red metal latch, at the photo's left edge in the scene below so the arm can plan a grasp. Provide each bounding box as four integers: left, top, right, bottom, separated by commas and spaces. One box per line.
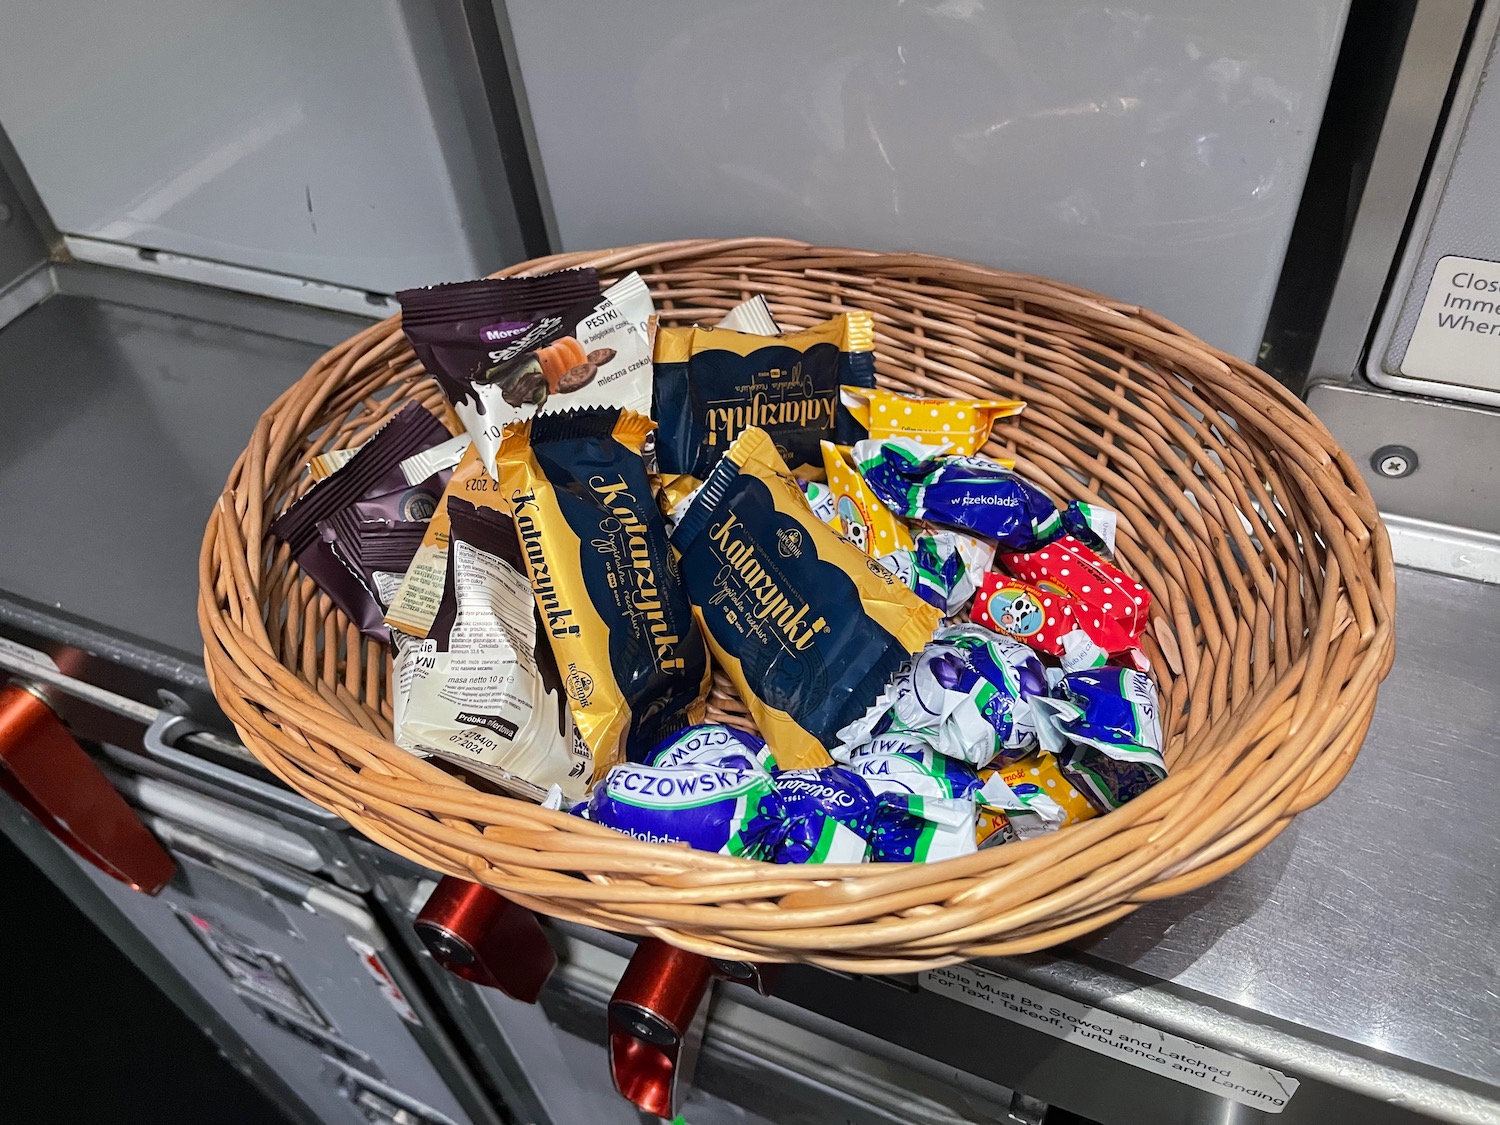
0, 683, 177, 894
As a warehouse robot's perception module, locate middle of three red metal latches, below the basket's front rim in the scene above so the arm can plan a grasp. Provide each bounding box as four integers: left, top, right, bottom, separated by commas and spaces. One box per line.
413, 876, 558, 1004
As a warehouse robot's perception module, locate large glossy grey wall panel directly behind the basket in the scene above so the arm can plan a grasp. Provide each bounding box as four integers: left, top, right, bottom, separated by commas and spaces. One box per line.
506, 0, 1347, 359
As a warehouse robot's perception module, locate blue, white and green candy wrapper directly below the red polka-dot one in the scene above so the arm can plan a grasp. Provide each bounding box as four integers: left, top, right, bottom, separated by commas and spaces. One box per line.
1038, 668, 1167, 812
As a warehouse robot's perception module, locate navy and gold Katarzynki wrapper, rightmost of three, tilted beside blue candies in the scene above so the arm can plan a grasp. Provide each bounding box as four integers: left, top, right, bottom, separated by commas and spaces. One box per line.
672, 428, 939, 770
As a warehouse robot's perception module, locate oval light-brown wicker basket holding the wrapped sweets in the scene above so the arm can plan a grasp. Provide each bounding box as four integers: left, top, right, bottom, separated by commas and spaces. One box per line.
198, 239, 1395, 972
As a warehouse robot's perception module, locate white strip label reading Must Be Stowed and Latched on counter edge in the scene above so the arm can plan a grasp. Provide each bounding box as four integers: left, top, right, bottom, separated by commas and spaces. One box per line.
918, 965, 1301, 1113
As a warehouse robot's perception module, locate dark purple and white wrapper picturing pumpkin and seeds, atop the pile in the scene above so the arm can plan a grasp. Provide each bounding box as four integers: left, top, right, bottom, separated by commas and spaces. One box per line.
398, 270, 653, 471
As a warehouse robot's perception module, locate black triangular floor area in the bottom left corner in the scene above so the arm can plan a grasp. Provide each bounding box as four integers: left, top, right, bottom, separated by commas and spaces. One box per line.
0, 836, 288, 1125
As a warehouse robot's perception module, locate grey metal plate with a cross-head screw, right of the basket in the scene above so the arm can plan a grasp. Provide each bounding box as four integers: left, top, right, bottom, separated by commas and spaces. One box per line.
1308, 383, 1500, 533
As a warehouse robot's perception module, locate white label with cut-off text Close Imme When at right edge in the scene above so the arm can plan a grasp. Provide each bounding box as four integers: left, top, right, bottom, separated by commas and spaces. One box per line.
1401, 255, 1500, 390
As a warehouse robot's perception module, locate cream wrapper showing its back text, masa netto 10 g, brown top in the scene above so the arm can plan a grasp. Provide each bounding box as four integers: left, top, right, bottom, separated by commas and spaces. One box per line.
392, 500, 594, 801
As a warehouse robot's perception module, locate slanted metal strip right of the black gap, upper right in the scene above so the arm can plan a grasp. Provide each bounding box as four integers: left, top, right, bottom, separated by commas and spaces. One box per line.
1310, 0, 1475, 381
